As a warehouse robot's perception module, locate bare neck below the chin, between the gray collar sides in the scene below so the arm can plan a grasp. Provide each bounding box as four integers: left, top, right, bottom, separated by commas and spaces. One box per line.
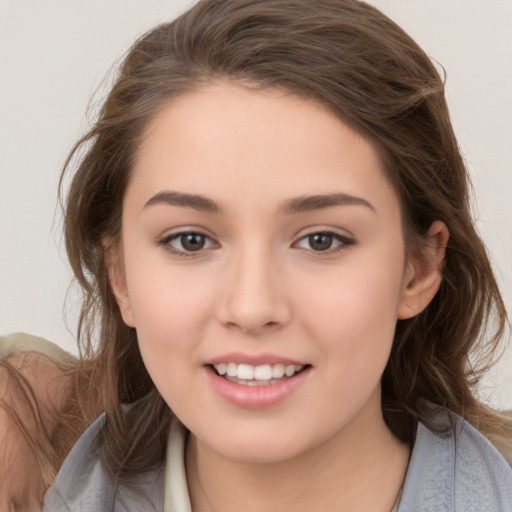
186, 396, 410, 512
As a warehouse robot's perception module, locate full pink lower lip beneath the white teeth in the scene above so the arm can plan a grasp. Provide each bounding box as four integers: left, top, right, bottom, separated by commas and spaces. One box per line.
204, 366, 311, 409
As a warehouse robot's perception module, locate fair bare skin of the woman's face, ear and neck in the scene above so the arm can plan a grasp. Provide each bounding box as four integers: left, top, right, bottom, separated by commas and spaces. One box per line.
110, 83, 448, 512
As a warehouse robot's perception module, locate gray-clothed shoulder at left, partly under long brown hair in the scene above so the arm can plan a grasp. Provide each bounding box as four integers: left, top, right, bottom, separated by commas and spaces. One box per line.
43, 415, 164, 512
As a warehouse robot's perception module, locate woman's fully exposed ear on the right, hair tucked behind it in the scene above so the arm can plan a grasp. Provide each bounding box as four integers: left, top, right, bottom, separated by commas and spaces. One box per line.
398, 221, 450, 320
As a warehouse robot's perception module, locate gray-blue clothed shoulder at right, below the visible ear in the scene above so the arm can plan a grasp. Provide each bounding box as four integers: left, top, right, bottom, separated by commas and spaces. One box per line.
399, 410, 512, 512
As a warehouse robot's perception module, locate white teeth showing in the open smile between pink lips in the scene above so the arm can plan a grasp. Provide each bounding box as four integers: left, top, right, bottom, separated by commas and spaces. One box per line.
207, 362, 311, 386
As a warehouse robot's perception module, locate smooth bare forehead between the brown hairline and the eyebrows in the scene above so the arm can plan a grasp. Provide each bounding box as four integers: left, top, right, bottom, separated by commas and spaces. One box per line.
127, 83, 396, 215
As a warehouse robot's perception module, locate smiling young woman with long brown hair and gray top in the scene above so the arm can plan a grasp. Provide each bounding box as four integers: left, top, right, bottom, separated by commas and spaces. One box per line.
1, 0, 512, 512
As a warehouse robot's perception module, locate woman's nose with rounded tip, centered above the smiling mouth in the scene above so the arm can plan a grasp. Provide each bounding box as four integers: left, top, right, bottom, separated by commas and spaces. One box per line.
214, 248, 291, 336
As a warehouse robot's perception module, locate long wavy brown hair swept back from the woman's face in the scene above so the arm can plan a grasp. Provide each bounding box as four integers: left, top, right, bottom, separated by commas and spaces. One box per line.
21, 0, 512, 488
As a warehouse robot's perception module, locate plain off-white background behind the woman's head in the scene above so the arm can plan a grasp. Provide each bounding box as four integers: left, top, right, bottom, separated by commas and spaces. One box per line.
0, 0, 512, 408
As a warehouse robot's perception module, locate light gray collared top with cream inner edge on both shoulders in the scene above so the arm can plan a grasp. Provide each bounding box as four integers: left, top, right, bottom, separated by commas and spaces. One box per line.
43, 413, 512, 512
